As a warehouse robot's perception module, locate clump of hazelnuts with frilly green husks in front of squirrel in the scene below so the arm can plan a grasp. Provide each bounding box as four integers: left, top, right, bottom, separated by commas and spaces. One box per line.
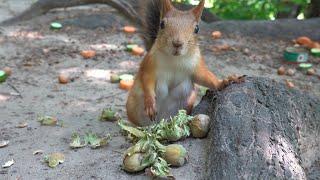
118, 110, 193, 177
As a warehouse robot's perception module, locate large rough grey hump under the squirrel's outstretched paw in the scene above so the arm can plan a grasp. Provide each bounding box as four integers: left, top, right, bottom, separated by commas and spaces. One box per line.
194, 78, 320, 180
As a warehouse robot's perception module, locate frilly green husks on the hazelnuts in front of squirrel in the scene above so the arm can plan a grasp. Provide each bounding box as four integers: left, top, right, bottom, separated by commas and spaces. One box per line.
118, 110, 193, 177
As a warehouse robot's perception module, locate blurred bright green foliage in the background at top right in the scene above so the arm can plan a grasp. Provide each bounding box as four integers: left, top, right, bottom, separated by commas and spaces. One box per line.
176, 0, 310, 20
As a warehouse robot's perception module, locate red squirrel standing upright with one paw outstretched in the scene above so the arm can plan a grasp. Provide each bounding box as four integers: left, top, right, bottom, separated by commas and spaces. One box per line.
126, 0, 241, 126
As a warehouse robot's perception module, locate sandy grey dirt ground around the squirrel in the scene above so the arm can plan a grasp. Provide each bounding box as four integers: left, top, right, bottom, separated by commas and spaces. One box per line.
0, 0, 320, 180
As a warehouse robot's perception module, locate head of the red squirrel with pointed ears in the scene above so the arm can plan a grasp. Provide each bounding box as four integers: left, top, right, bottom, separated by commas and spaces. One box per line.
155, 0, 205, 56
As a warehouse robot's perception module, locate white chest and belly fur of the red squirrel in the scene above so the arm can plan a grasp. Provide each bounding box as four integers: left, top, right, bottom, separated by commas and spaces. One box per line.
154, 49, 200, 124
